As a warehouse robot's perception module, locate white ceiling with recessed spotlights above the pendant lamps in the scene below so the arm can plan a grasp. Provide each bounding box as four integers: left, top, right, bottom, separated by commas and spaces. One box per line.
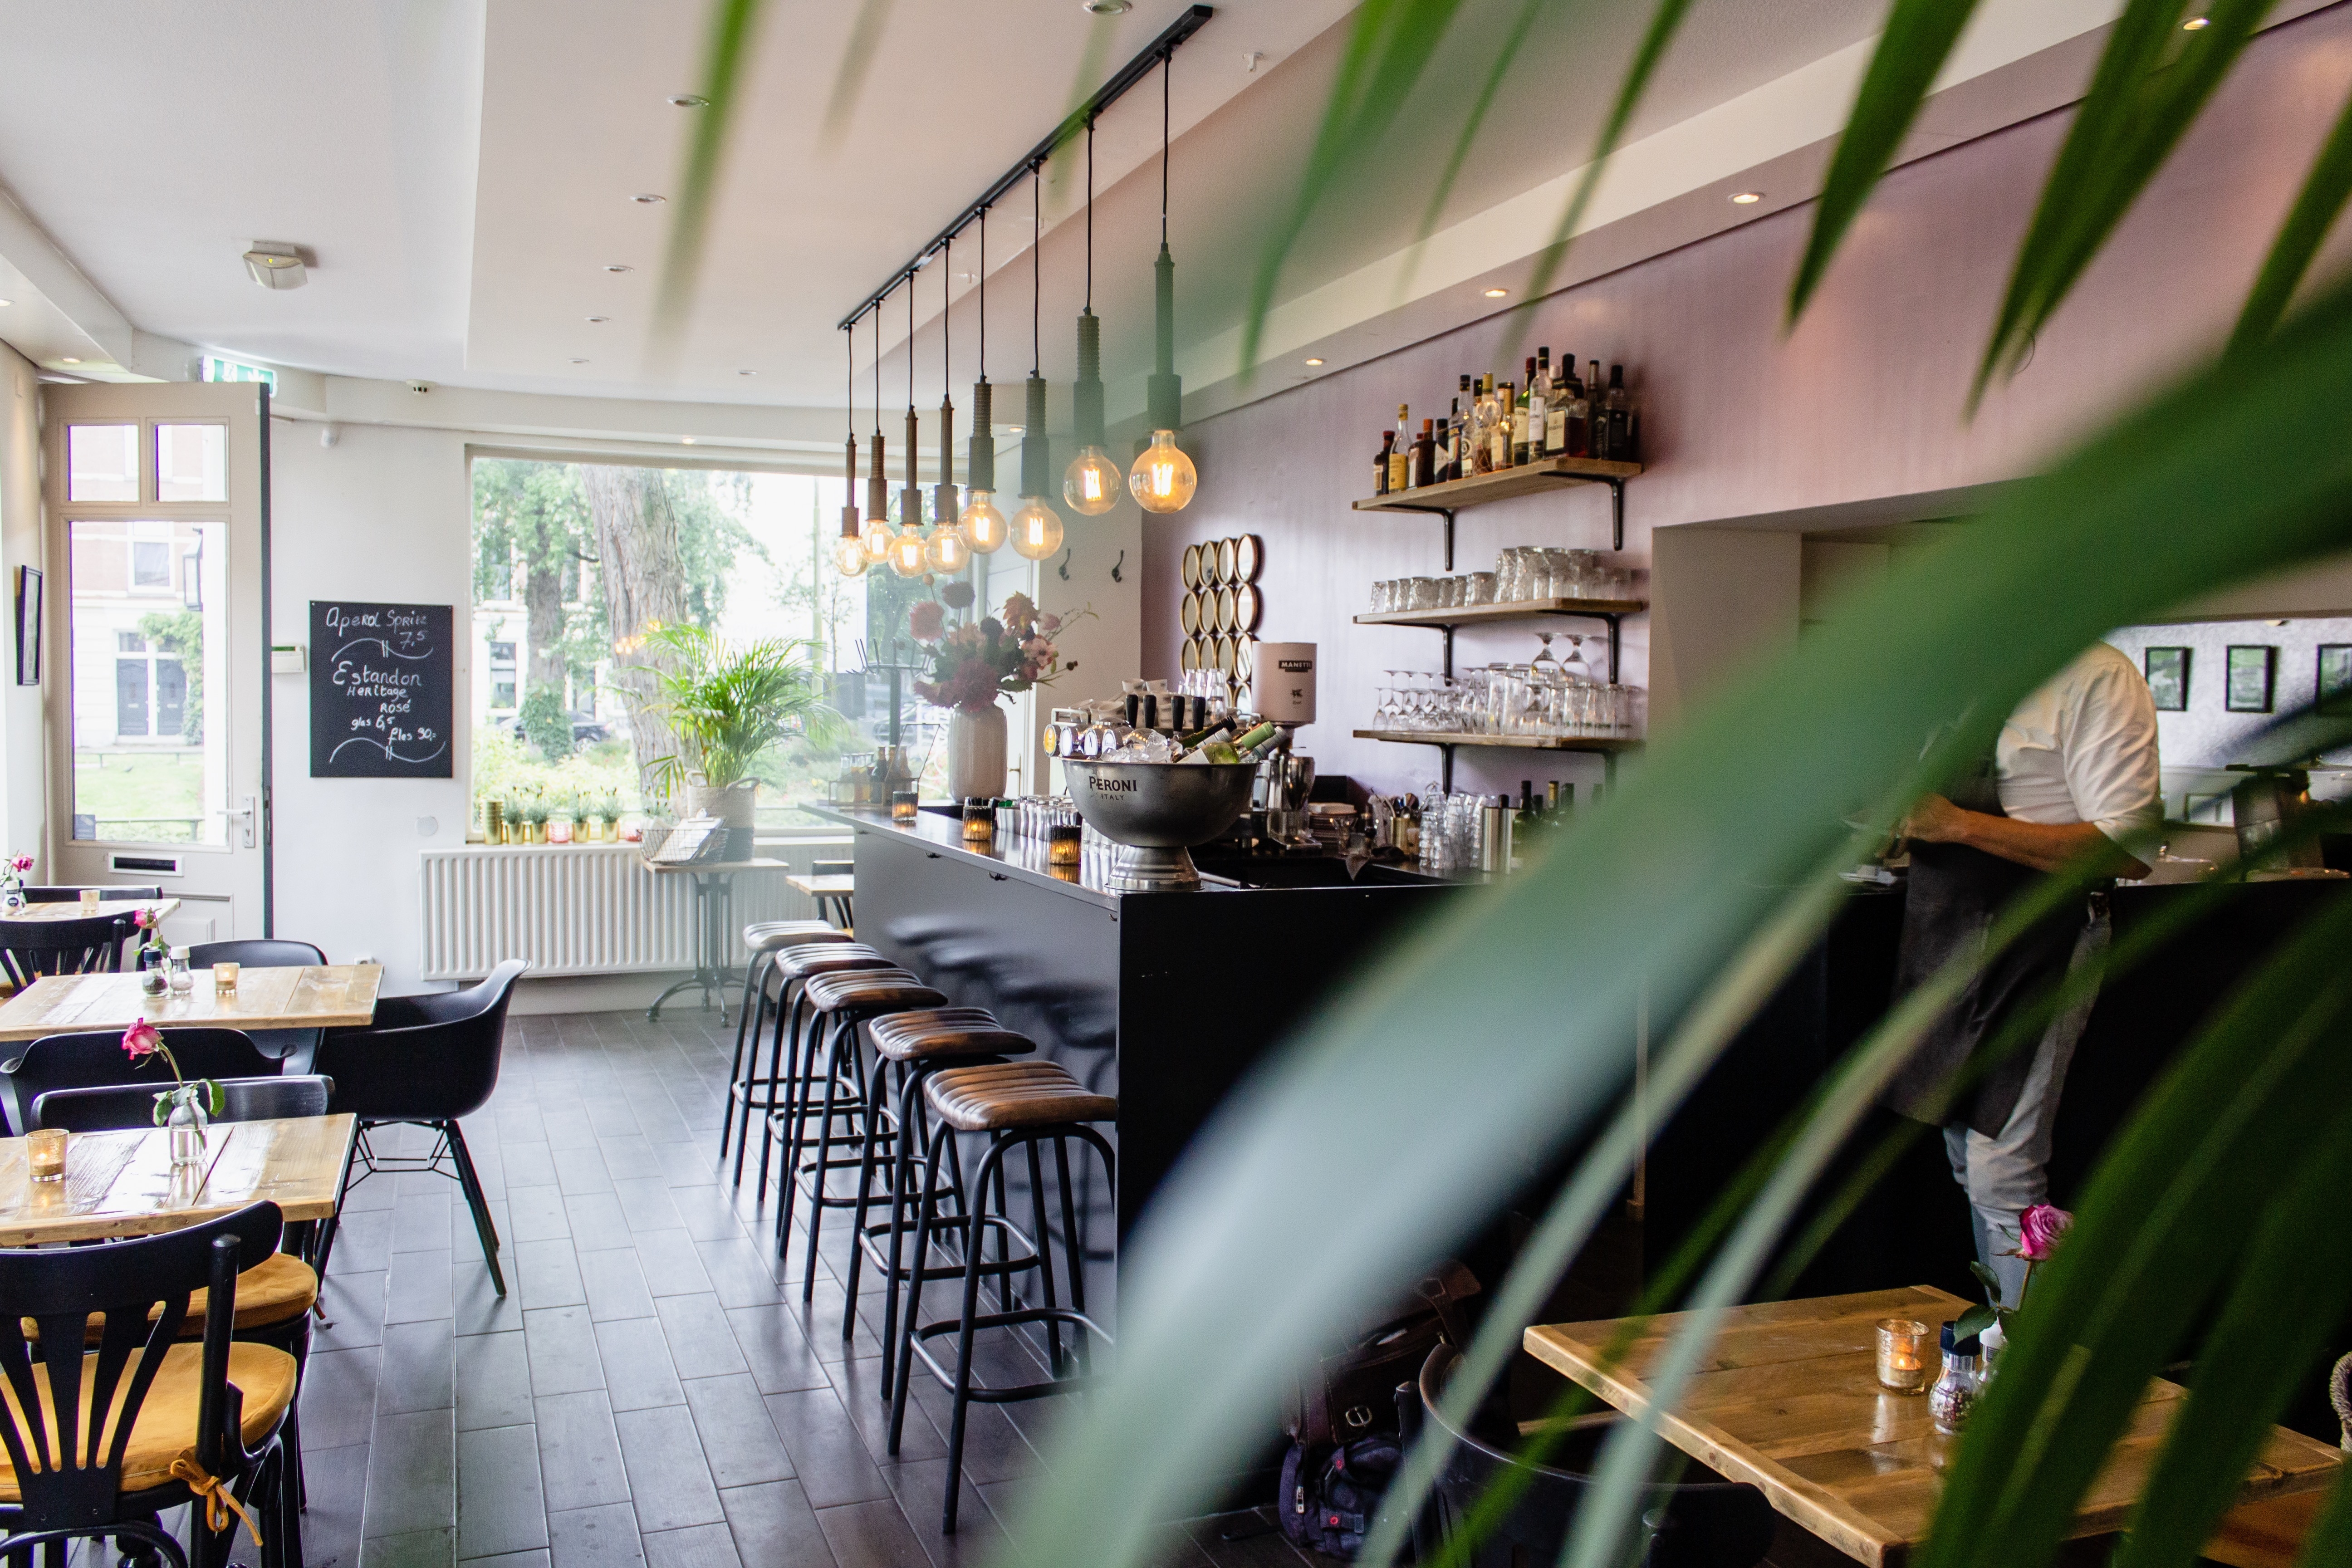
0, 0, 2154, 440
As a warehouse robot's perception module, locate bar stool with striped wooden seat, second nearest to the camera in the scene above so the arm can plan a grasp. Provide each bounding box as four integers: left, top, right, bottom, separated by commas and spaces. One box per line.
842, 1006, 1037, 1399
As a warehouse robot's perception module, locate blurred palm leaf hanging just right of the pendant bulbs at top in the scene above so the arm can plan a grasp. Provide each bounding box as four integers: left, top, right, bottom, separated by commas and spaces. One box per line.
1242, 0, 1460, 376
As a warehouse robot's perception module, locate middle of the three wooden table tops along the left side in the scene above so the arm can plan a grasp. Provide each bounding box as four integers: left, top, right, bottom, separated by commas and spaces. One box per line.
0, 964, 383, 1041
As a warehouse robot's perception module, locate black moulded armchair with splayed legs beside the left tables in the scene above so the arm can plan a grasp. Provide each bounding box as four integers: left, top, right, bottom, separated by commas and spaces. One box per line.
313, 959, 532, 1295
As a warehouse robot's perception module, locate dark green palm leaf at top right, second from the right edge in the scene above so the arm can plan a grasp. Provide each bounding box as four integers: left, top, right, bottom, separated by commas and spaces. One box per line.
1971, 0, 2274, 397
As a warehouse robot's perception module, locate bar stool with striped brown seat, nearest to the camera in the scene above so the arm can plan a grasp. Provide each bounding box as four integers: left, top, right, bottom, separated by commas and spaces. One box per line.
884, 1063, 1120, 1535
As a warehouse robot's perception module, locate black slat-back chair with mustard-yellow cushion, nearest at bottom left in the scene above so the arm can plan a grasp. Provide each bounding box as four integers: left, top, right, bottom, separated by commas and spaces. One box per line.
0, 1204, 301, 1568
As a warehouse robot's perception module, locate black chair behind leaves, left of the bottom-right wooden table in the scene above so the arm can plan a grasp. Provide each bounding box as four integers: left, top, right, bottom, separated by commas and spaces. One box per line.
1397, 1345, 1774, 1568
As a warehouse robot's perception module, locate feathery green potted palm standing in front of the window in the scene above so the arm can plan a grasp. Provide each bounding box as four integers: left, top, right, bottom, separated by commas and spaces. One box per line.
642, 625, 842, 846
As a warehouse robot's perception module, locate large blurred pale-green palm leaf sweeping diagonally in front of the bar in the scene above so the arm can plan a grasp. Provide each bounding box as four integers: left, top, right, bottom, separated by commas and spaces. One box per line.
1016, 257, 2352, 1563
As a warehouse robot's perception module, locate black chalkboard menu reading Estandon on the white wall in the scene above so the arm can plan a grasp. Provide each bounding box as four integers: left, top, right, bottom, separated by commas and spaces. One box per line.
310, 599, 456, 778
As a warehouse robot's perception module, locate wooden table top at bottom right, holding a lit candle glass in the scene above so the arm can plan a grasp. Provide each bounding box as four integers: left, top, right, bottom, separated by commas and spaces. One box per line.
1526, 1286, 2342, 1566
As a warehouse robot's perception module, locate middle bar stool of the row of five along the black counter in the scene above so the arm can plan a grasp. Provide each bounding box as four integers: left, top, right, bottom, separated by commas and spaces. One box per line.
781, 969, 948, 1312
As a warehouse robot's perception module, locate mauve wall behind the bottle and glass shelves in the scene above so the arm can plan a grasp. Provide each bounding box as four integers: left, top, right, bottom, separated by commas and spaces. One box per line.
1143, 7, 2352, 792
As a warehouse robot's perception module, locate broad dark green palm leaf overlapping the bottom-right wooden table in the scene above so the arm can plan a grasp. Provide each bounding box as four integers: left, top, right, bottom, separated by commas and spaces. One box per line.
1921, 900, 2352, 1568
